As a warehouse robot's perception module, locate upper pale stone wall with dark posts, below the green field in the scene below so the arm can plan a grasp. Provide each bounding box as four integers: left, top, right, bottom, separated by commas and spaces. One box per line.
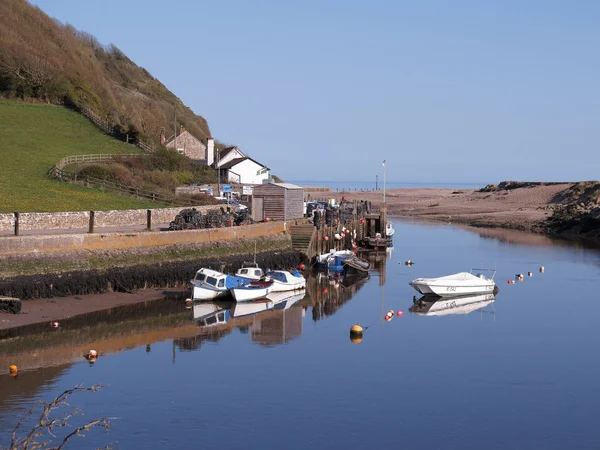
0, 205, 219, 232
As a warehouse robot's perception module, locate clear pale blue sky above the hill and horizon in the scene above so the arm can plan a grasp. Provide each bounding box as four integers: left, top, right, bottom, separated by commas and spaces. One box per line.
31, 0, 600, 184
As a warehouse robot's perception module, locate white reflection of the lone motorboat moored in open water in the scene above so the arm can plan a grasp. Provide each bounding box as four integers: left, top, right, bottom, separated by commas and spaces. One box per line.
409, 294, 496, 316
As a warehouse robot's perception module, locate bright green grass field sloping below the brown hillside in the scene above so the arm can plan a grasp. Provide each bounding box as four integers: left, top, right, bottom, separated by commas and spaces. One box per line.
0, 101, 160, 212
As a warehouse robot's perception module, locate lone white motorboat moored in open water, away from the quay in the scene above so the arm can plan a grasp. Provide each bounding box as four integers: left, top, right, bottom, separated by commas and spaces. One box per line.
409, 271, 496, 297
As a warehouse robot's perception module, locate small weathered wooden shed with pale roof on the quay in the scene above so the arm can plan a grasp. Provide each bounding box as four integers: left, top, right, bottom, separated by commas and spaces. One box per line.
252, 183, 304, 222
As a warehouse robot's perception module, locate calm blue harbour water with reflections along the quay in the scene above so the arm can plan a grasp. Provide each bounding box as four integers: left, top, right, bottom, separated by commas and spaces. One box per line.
0, 222, 600, 449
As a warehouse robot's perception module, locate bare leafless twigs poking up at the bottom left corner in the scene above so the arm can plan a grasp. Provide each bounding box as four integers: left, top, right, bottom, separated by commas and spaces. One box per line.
0, 385, 116, 450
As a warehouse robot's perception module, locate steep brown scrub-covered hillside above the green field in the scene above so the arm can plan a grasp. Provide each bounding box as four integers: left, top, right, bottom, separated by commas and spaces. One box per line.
0, 0, 210, 142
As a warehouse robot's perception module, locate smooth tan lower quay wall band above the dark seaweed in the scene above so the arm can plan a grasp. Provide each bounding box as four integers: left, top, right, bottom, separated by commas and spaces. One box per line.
0, 222, 287, 257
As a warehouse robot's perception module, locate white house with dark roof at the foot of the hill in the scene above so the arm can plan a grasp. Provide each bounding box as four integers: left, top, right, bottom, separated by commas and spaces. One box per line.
213, 147, 270, 184
